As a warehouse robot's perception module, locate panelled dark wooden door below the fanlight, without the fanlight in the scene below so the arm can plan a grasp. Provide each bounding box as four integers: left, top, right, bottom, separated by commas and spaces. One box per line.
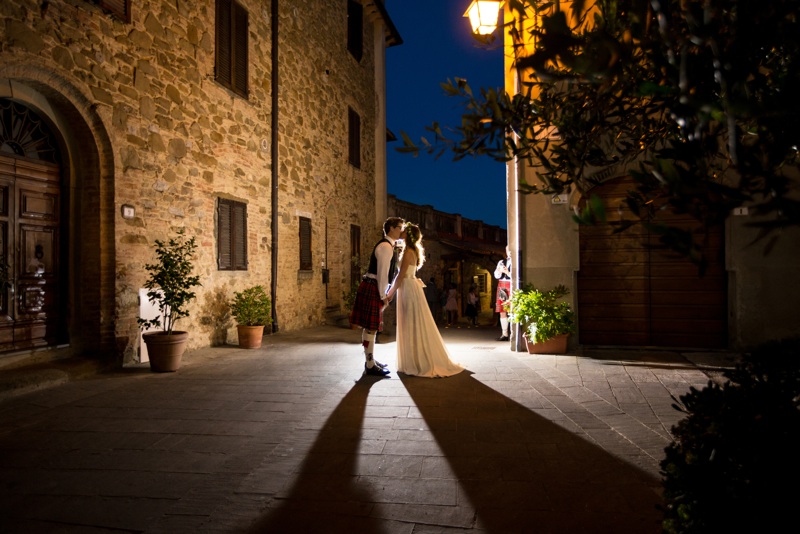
0, 156, 61, 351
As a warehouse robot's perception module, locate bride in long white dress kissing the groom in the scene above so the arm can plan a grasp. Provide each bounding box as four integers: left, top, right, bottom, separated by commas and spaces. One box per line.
387, 223, 464, 378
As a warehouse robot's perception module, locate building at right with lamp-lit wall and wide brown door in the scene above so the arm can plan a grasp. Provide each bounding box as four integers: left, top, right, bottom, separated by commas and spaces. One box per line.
488, 2, 800, 350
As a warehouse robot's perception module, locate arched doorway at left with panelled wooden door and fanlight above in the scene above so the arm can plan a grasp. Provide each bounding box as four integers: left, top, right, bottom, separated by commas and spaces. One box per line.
0, 98, 67, 352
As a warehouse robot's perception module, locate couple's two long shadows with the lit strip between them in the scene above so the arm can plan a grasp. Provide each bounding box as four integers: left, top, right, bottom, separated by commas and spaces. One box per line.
249, 370, 661, 533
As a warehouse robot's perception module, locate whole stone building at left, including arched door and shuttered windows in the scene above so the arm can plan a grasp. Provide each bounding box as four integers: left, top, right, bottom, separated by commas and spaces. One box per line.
0, 0, 401, 364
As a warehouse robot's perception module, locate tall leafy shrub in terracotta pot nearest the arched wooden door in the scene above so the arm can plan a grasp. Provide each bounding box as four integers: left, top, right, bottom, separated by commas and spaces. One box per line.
138, 229, 200, 372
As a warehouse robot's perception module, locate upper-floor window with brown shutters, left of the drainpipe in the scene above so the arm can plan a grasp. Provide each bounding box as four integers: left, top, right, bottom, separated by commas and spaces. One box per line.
214, 0, 248, 98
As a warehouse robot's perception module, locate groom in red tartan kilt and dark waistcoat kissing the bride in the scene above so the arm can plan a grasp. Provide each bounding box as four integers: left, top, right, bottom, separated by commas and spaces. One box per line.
350, 217, 405, 377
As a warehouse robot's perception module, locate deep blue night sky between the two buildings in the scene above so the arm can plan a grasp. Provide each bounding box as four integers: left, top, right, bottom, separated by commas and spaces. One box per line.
386, 0, 506, 228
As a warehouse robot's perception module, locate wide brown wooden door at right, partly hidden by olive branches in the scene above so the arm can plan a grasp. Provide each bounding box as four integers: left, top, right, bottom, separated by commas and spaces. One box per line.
578, 177, 727, 348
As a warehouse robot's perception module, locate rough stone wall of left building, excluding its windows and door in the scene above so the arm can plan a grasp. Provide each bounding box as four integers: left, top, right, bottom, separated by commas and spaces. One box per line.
0, 0, 384, 361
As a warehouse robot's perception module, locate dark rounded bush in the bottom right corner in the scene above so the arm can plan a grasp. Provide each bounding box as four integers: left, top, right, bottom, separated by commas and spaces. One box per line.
661, 339, 800, 534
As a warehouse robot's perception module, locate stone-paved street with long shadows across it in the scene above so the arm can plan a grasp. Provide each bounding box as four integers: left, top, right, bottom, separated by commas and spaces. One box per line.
0, 327, 730, 534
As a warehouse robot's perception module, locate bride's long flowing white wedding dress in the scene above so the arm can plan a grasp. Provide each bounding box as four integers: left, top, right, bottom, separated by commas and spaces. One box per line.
397, 262, 464, 378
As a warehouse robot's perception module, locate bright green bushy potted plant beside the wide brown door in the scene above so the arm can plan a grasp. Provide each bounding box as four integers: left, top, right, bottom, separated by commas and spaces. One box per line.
508, 284, 575, 354
